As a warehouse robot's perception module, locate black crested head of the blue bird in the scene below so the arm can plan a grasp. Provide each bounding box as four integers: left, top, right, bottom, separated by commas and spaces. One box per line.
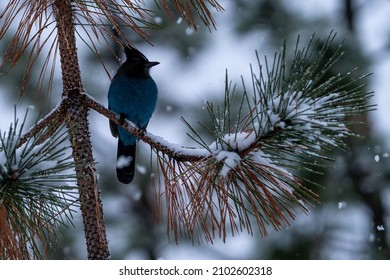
118, 45, 160, 78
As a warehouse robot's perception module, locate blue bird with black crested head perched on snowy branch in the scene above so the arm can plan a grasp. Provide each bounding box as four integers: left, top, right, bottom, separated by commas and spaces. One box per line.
108, 46, 159, 184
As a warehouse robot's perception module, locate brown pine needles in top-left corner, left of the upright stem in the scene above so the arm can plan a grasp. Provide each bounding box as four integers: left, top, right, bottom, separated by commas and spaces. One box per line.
0, 0, 56, 94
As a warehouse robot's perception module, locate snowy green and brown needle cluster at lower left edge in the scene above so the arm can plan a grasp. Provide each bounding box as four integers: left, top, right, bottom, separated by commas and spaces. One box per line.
0, 108, 78, 259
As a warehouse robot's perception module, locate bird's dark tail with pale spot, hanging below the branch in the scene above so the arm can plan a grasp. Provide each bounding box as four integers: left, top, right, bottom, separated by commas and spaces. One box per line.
116, 138, 136, 184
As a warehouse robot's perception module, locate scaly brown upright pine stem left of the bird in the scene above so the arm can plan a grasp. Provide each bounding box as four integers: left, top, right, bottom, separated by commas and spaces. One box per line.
54, 0, 110, 259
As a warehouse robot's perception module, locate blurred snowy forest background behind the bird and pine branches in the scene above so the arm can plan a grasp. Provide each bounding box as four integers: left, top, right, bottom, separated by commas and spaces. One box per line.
0, 0, 390, 259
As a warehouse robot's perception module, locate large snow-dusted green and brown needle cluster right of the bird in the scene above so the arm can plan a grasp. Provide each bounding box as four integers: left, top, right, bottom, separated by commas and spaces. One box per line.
161, 33, 373, 241
